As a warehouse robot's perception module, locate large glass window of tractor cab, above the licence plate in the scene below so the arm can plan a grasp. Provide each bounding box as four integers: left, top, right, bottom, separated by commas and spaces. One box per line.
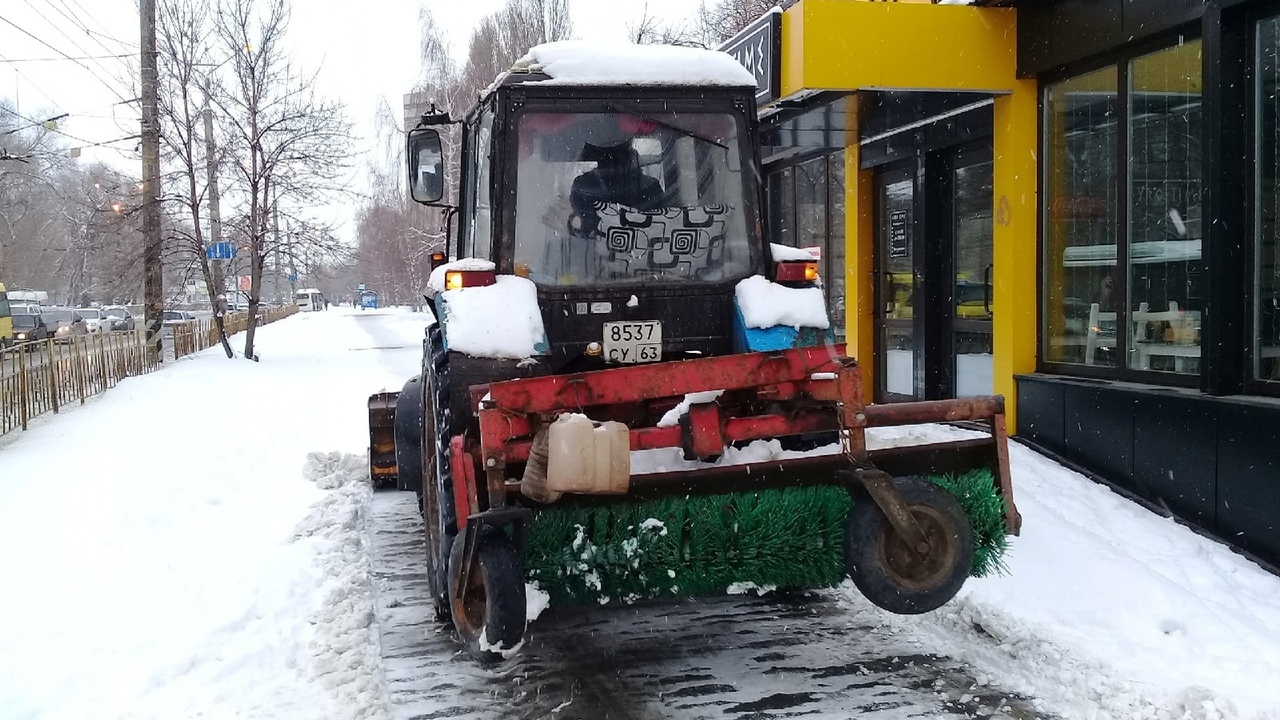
515, 111, 753, 286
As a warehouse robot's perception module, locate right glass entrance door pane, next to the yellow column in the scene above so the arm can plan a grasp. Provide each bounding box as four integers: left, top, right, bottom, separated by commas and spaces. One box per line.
946, 146, 996, 397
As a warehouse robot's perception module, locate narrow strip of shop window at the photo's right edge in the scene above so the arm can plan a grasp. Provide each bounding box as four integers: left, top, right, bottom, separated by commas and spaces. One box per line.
1251, 18, 1280, 386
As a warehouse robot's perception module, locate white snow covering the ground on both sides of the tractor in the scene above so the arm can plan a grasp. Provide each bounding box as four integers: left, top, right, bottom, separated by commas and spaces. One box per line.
0, 309, 1280, 720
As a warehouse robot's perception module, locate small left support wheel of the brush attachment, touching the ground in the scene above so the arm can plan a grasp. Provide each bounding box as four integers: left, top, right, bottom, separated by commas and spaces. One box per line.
449, 529, 526, 662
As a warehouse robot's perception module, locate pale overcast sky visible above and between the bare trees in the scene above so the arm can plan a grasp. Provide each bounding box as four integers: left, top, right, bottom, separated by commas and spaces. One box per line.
0, 0, 696, 237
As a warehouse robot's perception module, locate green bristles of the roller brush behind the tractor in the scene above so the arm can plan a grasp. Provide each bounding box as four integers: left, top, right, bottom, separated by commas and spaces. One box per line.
525, 471, 1006, 603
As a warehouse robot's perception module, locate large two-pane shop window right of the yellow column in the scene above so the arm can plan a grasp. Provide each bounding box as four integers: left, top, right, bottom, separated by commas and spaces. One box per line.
1043, 40, 1207, 375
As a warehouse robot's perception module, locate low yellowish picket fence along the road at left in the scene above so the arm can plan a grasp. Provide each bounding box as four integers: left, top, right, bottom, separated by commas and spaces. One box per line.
0, 306, 298, 436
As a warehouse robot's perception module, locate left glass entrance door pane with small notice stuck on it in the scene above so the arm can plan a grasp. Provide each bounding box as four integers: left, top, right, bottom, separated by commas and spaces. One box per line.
876, 163, 924, 401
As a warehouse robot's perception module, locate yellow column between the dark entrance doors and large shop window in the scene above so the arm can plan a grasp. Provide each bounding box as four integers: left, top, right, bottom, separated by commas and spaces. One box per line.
992, 81, 1039, 433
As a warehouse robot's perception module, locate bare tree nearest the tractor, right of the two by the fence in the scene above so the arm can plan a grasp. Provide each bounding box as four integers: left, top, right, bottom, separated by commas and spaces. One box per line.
214, 0, 351, 359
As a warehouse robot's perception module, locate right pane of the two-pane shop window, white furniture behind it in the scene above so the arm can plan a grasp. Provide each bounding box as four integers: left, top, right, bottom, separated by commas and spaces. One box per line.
1126, 40, 1207, 374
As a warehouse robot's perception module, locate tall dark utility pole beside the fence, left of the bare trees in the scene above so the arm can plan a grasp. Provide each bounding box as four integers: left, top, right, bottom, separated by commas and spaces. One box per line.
138, 0, 164, 359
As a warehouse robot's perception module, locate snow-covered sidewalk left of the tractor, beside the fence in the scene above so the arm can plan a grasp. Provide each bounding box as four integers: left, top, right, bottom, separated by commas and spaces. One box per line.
0, 311, 426, 719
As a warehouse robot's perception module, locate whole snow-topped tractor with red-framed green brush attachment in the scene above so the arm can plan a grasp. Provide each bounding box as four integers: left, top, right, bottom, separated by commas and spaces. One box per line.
369, 37, 1020, 659
